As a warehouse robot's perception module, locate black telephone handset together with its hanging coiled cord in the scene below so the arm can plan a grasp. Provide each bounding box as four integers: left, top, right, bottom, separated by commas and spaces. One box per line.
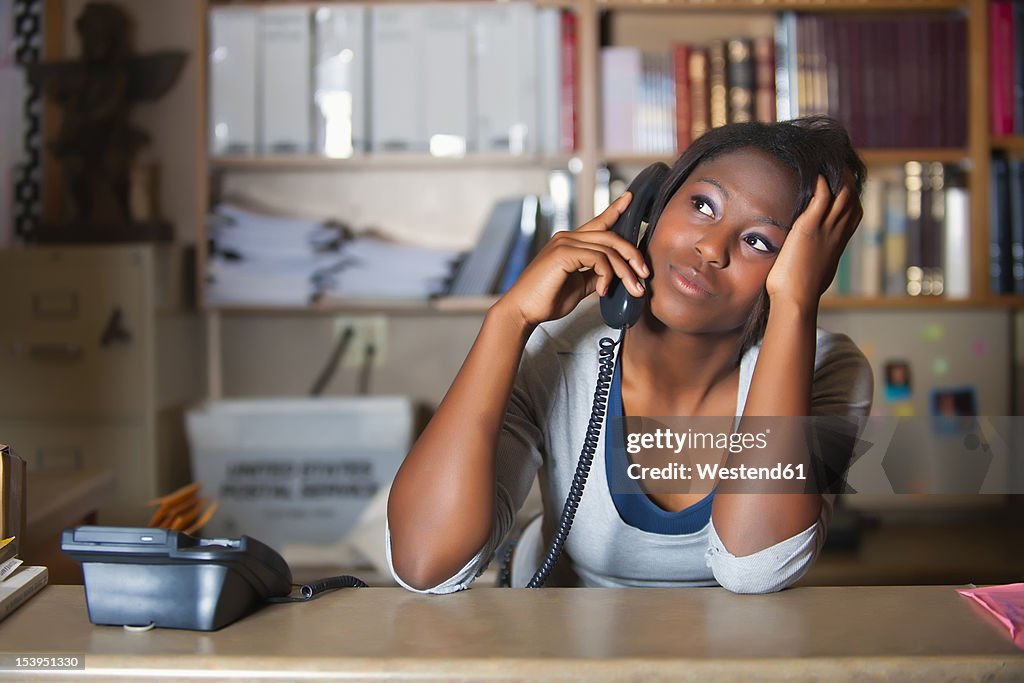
516, 162, 669, 588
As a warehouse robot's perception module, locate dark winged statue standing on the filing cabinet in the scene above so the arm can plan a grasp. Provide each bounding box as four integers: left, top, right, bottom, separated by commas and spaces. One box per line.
29, 2, 185, 242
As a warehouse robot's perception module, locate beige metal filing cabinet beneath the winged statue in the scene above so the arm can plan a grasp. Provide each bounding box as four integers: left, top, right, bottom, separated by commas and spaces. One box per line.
0, 245, 205, 524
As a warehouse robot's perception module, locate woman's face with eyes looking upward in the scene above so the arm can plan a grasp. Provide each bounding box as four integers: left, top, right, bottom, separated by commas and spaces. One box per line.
647, 148, 797, 333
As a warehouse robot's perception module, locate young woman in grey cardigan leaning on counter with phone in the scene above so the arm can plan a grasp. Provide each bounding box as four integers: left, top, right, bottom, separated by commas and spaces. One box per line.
387, 117, 872, 593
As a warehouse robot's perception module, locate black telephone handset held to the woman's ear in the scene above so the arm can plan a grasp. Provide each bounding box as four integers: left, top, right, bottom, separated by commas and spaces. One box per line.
601, 162, 669, 330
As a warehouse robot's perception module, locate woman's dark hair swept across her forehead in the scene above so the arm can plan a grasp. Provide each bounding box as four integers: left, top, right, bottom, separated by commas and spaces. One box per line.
650, 116, 867, 362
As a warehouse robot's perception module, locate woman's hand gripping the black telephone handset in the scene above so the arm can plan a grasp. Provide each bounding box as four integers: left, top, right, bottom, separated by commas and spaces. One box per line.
496, 193, 650, 328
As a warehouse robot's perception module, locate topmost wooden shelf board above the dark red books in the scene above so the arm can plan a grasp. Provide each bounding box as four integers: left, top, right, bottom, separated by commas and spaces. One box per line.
597, 0, 969, 12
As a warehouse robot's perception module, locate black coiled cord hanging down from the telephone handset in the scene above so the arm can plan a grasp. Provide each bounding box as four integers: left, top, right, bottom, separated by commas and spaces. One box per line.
528, 330, 626, 588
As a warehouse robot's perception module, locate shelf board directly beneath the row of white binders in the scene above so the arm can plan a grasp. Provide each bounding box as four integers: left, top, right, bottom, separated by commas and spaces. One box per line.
210, 154, 571, 172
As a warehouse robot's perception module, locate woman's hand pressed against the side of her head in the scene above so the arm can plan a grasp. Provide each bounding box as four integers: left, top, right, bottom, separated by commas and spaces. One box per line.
765, 173, 864, 310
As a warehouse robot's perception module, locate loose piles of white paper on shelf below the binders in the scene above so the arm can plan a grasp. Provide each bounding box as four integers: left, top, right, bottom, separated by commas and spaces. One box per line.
207, 205, 460, 306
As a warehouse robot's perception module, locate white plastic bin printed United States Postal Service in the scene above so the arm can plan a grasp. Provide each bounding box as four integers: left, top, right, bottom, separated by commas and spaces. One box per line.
186, 396, 413, 549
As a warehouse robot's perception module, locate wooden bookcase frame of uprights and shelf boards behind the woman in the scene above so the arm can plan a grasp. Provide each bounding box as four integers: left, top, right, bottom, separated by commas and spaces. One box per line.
198, 0, 1007, 396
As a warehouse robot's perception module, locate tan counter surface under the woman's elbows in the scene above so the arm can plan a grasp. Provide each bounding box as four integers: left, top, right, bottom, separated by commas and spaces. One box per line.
0, 586, 1024, 683
